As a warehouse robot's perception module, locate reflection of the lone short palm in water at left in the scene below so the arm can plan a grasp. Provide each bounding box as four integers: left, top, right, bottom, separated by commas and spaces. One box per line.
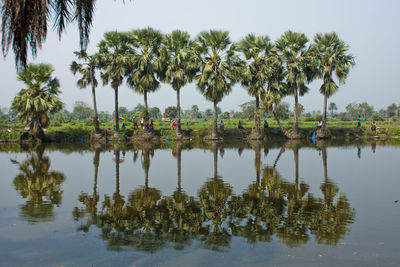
14, 146, 65, 223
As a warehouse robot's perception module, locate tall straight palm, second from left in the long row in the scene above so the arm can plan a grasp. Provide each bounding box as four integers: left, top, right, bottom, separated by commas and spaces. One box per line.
97, 31, 129, 135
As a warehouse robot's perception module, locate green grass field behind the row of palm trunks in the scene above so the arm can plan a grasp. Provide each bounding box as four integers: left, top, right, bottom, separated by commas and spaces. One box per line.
0, 118, 400, 142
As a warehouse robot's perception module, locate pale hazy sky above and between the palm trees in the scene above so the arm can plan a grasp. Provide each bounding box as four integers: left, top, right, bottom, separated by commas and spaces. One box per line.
0, 0, 400, 111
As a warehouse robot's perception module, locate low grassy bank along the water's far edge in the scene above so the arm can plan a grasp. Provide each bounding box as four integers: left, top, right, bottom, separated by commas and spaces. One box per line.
0, 126, 400, 143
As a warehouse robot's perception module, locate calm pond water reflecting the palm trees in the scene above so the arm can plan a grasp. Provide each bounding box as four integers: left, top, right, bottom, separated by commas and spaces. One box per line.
0, 142, 400, 266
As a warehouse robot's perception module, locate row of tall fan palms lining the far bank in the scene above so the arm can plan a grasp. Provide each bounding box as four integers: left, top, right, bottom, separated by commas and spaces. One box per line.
71, 27, 355, 139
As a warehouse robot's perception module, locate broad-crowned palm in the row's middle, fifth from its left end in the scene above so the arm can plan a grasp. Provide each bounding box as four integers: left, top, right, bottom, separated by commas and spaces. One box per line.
196, 30, 240, 139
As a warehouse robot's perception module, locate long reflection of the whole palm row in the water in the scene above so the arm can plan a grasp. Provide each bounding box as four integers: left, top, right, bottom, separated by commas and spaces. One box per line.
73, 142, 355, 253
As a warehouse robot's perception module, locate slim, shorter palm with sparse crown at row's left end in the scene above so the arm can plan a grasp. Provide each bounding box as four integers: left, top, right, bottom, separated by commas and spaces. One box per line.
70, 50, 100, 134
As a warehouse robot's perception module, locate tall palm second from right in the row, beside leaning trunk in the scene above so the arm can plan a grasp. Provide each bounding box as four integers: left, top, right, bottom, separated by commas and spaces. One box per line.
276, 31, 312, 139
